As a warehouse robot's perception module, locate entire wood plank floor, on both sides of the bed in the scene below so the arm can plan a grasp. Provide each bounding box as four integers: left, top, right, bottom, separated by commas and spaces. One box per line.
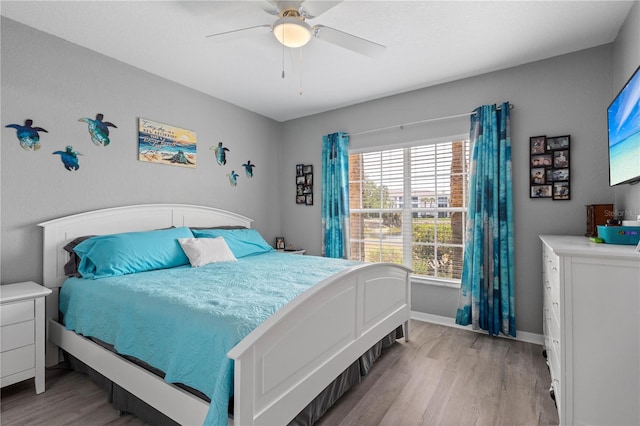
0, 321, 558, 426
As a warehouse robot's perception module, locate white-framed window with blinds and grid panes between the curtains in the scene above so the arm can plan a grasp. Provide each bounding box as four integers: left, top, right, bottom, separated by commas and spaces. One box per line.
349, 140, 469, 283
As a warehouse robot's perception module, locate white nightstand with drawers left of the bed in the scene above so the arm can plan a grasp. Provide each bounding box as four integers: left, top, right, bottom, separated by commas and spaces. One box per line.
0, 281, 51, 393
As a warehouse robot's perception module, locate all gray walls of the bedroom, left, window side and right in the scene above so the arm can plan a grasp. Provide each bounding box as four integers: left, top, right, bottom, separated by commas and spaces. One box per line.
0, 3, 640, 333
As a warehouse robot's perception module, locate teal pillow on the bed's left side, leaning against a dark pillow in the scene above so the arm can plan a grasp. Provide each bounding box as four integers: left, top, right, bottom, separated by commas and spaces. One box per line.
73, 226, 193, 279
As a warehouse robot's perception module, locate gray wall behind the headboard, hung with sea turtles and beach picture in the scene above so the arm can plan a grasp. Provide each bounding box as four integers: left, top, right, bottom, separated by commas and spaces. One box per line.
1, 18, 281, 284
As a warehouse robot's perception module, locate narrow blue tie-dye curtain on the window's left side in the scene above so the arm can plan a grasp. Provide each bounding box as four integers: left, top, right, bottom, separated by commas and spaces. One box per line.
322, 132, 349, 259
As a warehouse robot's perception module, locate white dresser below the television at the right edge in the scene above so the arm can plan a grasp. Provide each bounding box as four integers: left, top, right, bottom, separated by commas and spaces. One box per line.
540, 235, 640, 425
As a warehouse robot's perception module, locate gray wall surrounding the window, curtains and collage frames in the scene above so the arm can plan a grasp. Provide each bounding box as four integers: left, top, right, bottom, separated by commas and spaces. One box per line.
279, 45, 614, 333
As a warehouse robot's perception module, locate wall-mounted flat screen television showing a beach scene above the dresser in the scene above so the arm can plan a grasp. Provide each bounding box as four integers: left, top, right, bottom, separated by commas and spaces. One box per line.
607, 67, 640, 186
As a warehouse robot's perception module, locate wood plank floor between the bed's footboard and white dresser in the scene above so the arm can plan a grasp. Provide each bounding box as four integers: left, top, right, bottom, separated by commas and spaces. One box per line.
319, 321, 558, 426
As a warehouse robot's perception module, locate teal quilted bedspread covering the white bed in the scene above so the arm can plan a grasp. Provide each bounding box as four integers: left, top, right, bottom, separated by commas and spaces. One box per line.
60, 252, 357, 425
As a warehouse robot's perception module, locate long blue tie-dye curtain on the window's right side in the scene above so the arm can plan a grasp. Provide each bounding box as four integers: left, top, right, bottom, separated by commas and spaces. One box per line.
456, 102, 516, 337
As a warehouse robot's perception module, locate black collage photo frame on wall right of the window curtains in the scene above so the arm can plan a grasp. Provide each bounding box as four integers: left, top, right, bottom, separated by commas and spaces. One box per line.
529, 135, 571, 200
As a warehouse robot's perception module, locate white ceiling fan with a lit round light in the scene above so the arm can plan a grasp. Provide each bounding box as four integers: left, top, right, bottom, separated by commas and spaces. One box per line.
206, 0, 385, 56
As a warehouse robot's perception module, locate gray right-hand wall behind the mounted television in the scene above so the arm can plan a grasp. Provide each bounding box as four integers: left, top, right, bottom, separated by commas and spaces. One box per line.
613, 1, 640, 220
